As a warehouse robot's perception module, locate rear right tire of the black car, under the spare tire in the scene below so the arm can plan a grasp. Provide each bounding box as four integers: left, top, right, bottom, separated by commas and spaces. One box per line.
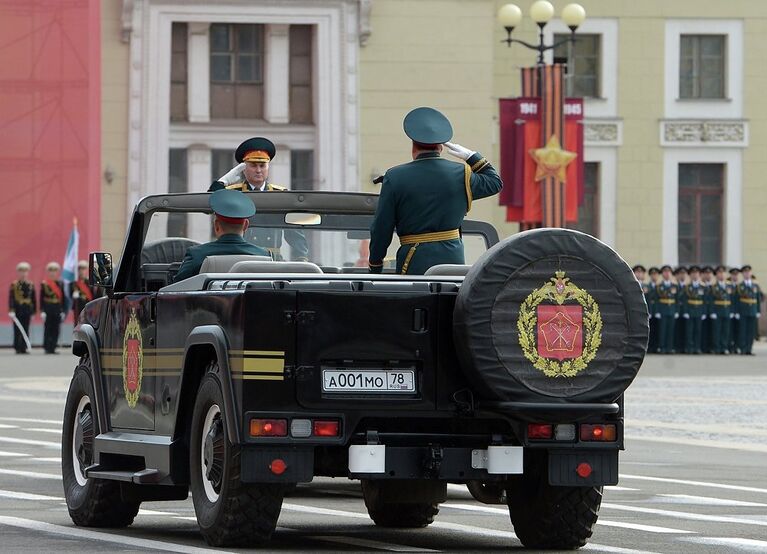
507, 450, 602, 550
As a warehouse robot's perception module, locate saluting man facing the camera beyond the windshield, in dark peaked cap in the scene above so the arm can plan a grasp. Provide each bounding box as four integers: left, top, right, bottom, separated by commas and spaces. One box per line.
208, 137, 309, 262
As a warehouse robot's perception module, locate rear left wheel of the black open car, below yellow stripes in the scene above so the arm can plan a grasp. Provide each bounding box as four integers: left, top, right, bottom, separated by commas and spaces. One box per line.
189, 364, 284, 546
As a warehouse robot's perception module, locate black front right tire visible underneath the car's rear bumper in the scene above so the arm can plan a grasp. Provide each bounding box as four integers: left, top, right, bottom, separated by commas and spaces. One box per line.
362, 480, 439, 529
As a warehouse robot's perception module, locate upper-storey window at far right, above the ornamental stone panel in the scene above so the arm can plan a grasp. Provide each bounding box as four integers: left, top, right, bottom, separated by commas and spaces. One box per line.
679, 35, 727, 99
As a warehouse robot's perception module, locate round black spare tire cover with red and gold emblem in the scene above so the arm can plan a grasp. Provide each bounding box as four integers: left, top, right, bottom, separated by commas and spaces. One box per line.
453, 229, 649, 403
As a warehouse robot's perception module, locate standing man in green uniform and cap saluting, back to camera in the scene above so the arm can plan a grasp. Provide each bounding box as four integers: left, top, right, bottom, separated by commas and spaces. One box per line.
369, 107, 503, 275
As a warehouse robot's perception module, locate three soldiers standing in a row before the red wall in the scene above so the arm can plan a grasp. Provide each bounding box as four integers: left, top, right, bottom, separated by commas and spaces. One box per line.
8, 261, 101, 354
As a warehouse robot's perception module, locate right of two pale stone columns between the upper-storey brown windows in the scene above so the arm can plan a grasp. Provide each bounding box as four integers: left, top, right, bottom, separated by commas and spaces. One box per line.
264, 25, 290, 123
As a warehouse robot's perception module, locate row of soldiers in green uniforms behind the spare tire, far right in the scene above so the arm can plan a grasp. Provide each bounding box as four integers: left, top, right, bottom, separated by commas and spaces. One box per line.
633, 265, 762, 355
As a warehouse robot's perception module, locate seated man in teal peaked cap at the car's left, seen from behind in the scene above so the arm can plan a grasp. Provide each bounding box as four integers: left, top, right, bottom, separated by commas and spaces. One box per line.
174, 190, 269, 281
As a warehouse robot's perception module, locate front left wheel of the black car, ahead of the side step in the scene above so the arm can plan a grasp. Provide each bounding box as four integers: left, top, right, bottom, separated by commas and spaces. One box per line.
61, 357, 141, 527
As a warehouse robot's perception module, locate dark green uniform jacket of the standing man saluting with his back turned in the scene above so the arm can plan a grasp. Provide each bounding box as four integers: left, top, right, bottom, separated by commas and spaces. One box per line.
370, 152, 503, 275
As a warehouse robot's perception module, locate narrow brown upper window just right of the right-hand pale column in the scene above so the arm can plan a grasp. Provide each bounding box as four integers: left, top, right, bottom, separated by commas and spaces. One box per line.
290, 25, 314, 124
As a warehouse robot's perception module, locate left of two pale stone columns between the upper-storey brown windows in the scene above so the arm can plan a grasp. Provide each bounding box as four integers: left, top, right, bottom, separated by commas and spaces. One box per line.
186, 21, 210, 123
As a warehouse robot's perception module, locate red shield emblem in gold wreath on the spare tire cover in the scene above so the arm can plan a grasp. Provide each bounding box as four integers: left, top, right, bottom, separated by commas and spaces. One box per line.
517, 271, 602, 377
